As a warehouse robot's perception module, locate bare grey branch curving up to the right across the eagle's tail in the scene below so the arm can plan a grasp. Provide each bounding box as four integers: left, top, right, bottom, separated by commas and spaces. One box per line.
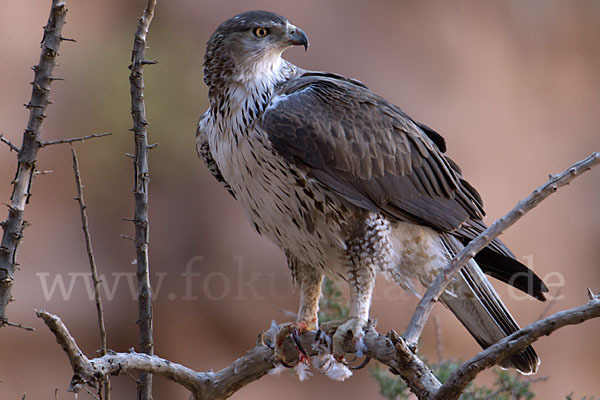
404, 153, 600, 346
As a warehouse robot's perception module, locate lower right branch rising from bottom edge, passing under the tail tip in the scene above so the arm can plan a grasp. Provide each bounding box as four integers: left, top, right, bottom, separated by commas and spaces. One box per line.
434, 296, 600, 400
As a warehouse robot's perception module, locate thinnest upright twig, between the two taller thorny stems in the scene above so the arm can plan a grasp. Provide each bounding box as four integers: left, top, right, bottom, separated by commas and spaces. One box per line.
71, 148, 110, 400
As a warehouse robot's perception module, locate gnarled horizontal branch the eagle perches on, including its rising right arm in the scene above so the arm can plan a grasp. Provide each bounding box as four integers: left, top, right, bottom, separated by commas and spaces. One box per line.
37, 296, 600, 400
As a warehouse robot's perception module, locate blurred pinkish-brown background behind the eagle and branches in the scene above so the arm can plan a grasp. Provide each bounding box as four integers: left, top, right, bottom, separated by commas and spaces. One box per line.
0, 0, 600, 400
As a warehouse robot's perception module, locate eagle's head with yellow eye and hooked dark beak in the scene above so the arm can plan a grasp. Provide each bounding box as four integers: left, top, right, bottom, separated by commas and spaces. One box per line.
204, 11, 308, 92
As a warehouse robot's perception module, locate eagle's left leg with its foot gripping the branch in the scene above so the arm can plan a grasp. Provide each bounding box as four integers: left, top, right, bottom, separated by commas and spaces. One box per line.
275, 254, 323, 361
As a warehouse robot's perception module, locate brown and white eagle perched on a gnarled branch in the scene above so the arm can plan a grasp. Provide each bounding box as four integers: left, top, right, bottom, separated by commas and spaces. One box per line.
196, 11, 548, 374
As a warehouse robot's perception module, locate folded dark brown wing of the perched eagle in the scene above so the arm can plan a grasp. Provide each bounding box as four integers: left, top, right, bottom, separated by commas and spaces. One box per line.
262, 73, 483, 231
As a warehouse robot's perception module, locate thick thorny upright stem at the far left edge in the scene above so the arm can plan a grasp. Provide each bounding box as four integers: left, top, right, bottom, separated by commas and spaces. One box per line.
0, 0, 67, 327
